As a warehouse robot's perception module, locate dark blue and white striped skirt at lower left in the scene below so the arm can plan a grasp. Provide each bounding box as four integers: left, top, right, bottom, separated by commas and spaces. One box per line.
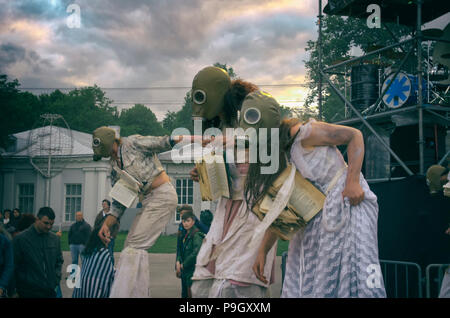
72, 248, 114, 298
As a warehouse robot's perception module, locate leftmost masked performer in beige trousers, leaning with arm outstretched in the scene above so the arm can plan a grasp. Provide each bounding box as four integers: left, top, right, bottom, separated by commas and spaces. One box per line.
92, 127, 199, 298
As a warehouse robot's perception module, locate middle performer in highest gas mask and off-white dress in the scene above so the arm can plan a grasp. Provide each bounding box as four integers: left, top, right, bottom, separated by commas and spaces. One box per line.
191, 67, 280, 298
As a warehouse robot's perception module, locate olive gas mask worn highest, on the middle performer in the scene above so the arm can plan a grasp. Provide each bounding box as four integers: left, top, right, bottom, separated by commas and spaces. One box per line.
191, 66, 231, 120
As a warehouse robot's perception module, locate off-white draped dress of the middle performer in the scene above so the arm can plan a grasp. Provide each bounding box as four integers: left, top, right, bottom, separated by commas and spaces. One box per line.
191, 164, 276, 298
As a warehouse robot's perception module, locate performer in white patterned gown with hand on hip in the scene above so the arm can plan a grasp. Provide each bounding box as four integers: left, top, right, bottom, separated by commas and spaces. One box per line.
250, 111, 386, 298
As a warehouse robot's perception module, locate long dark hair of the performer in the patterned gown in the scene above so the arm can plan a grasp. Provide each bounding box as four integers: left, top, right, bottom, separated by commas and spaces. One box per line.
244, 118, 301, 209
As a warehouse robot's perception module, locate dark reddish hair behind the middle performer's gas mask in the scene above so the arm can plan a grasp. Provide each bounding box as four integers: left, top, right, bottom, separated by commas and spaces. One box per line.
204, 78, 259, 129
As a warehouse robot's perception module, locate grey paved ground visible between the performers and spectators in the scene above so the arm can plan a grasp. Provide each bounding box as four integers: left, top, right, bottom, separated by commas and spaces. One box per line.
61, 252, 281, 298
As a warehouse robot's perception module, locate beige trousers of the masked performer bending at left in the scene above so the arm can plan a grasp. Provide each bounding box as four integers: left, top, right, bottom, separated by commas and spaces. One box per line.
110, 182, 178, 298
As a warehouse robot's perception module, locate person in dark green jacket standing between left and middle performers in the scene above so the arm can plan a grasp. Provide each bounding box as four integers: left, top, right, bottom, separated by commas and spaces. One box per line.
176, 211, 205, 298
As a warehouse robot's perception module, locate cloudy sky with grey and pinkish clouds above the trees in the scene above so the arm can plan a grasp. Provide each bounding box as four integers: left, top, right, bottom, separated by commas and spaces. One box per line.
0, 0, 448, 120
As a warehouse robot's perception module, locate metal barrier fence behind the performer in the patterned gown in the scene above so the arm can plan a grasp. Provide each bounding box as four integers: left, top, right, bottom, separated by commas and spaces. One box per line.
281, 252, 449, 298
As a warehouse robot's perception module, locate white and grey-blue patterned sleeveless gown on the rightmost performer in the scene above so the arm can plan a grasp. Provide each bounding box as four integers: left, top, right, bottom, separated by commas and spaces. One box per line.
281, 120, 386, 297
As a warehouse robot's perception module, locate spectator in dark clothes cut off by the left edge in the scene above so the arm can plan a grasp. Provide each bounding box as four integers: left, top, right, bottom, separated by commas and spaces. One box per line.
0, 224, 14, 298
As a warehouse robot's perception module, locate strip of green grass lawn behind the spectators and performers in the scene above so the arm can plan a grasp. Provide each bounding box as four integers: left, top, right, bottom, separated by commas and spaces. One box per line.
61, 232, 289, 256
